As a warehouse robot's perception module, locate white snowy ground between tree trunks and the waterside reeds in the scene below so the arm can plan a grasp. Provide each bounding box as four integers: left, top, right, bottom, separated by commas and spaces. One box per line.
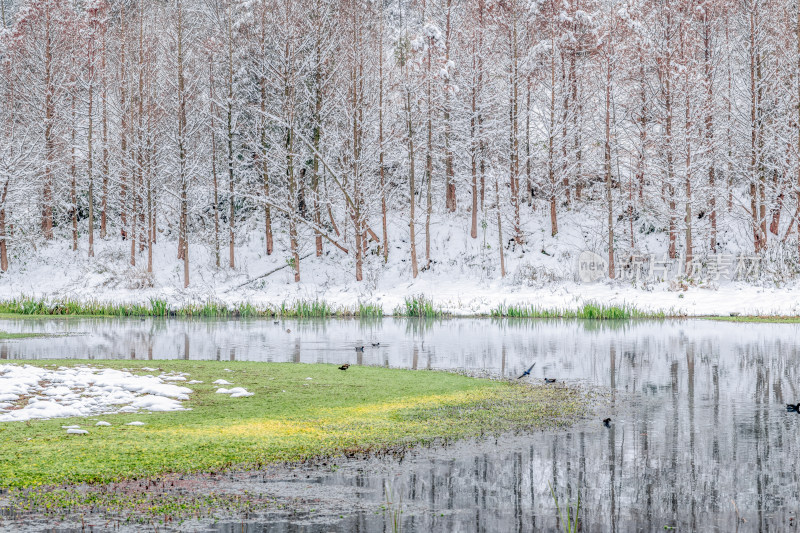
0, 207, 800, 315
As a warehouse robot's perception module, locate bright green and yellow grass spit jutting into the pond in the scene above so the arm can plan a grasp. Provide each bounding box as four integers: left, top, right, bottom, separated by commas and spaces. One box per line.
0, 361, 588, 488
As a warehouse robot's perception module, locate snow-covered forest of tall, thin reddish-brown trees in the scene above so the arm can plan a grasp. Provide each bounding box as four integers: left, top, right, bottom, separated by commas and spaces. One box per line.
0, 0, 800, 300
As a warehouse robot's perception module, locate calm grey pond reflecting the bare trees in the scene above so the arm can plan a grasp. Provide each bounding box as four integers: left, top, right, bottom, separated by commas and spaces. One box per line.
0, 319, 800, 532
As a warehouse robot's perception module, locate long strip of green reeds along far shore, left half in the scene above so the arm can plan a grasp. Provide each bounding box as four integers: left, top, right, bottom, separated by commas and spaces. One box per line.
0, 298, 383, 318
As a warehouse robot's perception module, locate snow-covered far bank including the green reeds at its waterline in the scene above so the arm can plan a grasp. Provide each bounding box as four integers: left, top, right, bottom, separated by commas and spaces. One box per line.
0, 222, 800, 317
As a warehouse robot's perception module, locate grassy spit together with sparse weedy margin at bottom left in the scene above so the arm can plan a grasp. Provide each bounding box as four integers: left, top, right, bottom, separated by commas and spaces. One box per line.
0, 361, 593, 521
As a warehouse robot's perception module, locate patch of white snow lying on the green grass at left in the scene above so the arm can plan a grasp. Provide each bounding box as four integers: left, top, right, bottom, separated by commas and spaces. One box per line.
0, 364, 192, 422
